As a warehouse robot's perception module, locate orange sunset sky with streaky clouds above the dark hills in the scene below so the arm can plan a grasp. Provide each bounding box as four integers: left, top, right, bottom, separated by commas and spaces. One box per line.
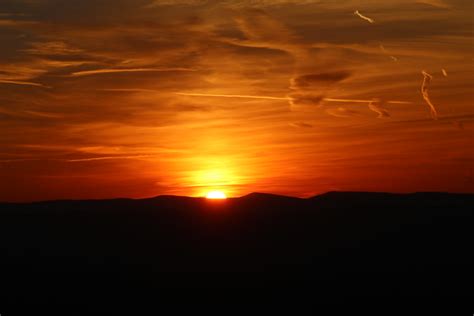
0, 0, 474, 201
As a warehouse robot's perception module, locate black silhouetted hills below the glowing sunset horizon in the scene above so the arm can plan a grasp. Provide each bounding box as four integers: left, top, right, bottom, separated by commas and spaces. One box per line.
0, 192, 474, 315
